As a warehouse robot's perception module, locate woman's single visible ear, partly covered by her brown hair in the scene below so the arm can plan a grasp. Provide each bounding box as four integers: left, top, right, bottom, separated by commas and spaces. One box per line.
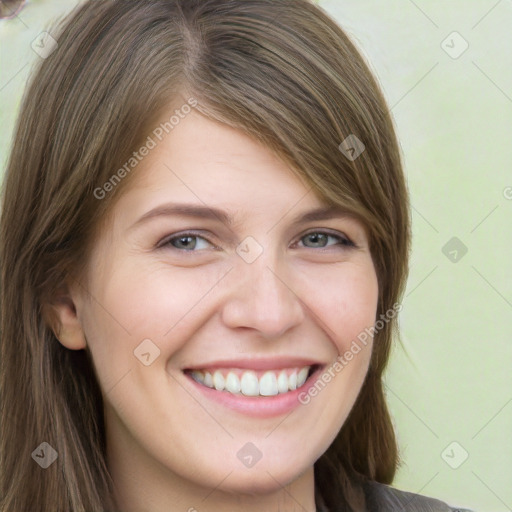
45, 285, 87, 350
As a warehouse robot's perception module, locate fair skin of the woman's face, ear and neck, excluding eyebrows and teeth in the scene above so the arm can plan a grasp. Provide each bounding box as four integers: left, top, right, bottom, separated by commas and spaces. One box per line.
57, 106, 378, 512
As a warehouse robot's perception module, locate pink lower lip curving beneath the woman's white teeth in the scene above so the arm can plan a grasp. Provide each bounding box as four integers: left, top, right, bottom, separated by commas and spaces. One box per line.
185, 368, 322, 418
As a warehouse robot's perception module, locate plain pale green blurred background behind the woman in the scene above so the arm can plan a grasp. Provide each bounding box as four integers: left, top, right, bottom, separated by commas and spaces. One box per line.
0, 0, 512, 512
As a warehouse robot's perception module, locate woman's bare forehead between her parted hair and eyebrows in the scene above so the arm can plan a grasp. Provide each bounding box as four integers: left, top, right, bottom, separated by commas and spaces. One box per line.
113, 108, 321, 220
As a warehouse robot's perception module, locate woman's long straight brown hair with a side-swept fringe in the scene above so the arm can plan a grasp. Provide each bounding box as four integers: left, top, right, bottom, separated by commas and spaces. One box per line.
0, 0, 410, 512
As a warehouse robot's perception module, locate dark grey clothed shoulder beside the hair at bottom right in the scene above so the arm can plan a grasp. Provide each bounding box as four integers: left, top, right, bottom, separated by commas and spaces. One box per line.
364, 482, 472, 512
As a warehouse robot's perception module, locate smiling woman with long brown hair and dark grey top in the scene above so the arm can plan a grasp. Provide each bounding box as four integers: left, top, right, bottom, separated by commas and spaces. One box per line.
0, 0, 472, 512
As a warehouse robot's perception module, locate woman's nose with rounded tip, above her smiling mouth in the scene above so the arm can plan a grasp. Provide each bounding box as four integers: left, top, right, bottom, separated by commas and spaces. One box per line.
222, 253, 304, 338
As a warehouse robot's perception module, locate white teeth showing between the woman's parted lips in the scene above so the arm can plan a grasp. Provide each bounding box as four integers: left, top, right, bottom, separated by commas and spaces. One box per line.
185, 365, 320, 397
